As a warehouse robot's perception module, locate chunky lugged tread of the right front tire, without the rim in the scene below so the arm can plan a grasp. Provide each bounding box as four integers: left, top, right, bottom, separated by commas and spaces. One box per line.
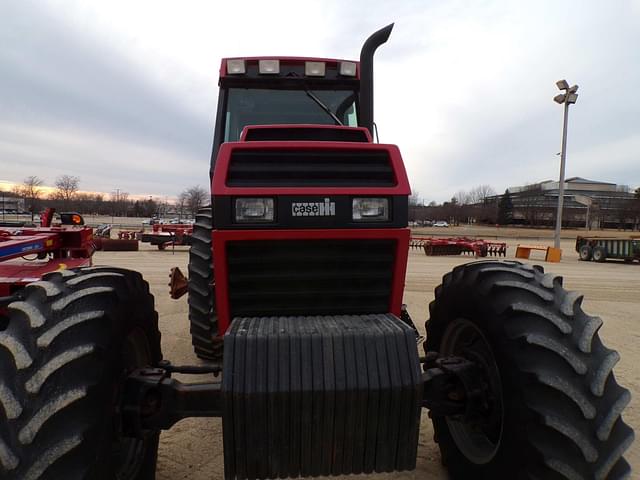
425, 261, 634, 480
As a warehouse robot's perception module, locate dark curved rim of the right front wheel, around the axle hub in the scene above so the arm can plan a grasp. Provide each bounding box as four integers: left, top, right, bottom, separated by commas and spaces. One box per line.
440, 319, 504, 465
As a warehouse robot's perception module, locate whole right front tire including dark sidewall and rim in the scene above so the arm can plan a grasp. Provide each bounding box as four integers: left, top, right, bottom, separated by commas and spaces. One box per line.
425, 261, 634, 480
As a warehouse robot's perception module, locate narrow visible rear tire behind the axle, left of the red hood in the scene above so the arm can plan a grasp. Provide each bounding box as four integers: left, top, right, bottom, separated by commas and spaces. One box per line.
188, 207, 222, 361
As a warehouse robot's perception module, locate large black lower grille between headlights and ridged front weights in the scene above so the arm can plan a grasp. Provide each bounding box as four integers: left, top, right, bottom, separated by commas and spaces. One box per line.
227, 240, 395, 318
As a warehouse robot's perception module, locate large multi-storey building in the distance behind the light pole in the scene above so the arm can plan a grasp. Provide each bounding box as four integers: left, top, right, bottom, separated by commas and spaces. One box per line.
488, 177, 640, 228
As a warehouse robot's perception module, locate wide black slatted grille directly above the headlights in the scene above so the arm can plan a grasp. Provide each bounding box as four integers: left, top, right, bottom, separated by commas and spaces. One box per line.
227, 149, 396, 187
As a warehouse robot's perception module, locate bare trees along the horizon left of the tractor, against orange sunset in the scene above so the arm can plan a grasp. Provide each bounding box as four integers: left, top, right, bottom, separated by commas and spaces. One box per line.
6, 175, 210, 218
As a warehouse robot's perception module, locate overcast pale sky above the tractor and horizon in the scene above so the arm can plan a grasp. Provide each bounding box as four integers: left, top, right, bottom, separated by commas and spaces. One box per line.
0, 0, 640, 201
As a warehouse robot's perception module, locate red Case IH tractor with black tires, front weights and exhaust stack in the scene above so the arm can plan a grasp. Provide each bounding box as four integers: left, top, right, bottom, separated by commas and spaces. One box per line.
0, 26, 633, 480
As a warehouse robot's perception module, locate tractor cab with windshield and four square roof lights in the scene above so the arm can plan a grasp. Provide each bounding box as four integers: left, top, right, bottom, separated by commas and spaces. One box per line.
218, 57, 360, 142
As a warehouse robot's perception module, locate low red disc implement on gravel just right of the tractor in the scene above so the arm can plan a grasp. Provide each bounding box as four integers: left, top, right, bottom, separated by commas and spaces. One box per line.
409, 236, 507, 257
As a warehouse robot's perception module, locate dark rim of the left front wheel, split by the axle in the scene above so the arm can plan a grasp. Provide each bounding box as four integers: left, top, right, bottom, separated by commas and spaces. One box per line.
112, 329, 151, 480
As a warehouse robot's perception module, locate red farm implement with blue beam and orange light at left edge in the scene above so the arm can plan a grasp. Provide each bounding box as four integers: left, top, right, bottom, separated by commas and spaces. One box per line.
0, 209, 95, 297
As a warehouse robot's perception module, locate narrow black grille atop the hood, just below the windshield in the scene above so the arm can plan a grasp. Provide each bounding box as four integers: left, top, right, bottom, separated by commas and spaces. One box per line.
245, 127, 369, 142
